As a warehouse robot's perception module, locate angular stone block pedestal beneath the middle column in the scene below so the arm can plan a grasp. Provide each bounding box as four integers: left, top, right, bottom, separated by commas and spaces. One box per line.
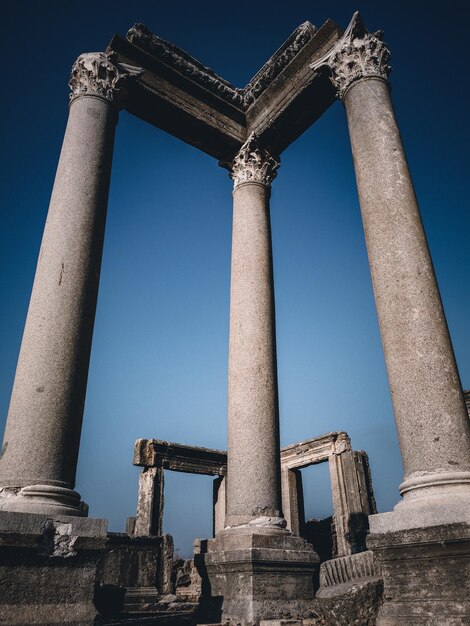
200, 528, 320, 626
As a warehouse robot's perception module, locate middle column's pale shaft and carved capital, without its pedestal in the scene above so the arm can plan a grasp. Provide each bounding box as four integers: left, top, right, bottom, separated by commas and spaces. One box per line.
226, 133, 285, 526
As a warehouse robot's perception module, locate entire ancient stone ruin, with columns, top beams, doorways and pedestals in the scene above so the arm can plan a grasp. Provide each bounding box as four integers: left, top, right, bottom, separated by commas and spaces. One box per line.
0, 9, 470, 626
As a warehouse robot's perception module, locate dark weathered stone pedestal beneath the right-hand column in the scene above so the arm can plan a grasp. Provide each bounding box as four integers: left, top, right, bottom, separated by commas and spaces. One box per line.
367, 514, 470, 626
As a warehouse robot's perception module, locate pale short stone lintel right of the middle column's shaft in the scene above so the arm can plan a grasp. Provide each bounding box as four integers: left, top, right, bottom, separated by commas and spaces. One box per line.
281, 432, 351, 469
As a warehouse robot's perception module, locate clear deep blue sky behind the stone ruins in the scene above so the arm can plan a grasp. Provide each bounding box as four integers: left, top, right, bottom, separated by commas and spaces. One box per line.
0, 0, 470, 553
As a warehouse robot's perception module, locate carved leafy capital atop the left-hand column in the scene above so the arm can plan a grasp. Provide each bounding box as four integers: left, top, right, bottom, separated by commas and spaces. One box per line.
69, 52, 142, 106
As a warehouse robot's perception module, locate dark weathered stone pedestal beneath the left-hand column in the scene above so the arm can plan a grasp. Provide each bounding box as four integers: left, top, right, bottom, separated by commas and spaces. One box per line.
0, 511, 107, 626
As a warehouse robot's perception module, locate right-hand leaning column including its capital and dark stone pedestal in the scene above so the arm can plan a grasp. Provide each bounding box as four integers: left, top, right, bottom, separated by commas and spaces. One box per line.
316, 15, 470, 626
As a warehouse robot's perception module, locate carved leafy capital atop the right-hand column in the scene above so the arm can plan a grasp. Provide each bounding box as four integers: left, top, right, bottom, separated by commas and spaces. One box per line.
328, 13, 391, 99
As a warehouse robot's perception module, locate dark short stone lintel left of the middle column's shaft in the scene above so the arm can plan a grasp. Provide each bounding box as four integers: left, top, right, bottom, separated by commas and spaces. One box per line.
133, 439, 227, 476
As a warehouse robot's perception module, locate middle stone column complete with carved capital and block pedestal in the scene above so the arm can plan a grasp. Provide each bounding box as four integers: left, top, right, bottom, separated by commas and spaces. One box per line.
203, 134, 319, 626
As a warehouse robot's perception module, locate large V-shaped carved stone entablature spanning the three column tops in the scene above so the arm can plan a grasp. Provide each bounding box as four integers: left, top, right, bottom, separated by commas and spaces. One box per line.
106, 20, 342, 161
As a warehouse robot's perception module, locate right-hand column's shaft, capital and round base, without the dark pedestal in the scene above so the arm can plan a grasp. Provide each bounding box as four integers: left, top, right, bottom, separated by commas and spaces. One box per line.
329, 15, 470, 521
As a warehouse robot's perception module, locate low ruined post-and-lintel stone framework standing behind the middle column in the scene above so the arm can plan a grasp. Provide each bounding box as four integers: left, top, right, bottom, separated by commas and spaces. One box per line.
133, 432, 376, 556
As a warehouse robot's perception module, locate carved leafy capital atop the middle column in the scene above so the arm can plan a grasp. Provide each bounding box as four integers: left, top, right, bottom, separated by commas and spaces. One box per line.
228, 133, 280, 189
